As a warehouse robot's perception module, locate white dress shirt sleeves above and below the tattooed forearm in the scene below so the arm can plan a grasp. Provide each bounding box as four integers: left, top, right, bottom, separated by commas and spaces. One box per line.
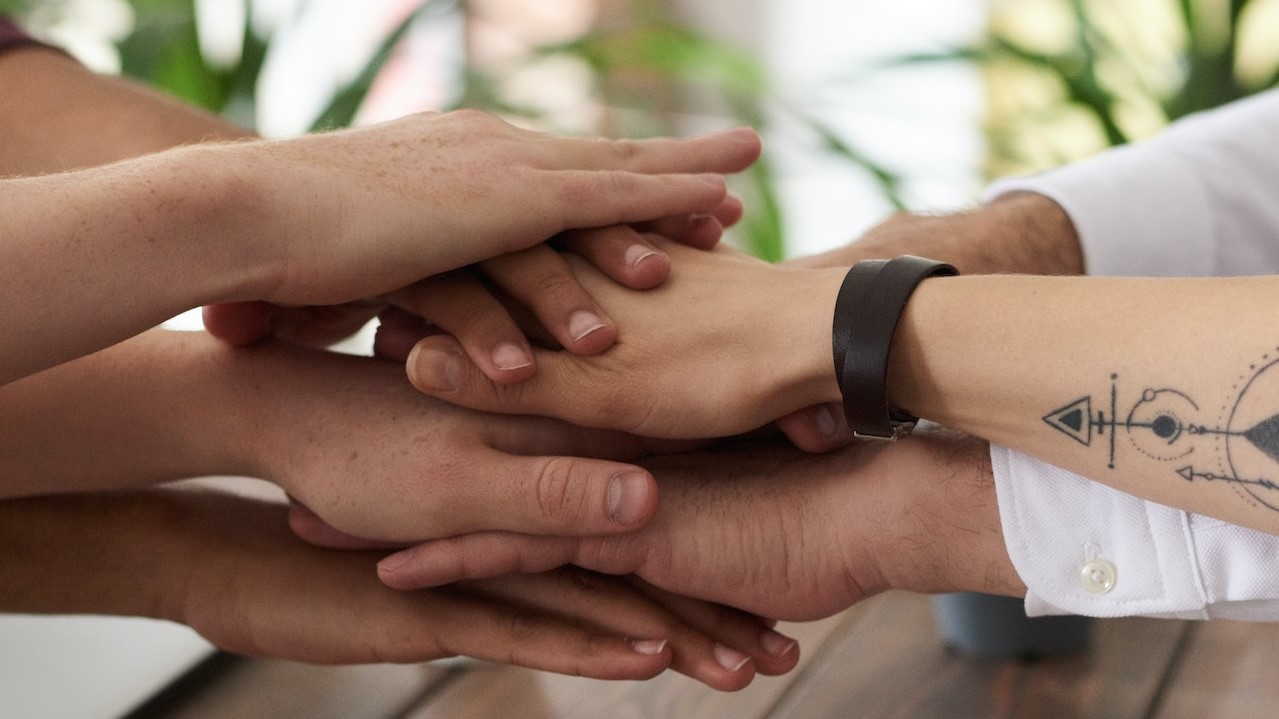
986, 91, 1279, 620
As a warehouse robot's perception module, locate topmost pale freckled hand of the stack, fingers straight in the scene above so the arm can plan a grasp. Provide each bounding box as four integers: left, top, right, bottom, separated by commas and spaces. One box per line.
202, 111, 760, 304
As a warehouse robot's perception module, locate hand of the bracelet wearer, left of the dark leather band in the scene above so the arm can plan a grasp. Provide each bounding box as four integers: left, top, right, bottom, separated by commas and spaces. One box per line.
393, 238, 844, 439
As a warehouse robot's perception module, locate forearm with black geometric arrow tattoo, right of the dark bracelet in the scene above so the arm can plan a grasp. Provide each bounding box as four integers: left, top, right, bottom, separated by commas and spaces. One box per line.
889, 276, 1279, 532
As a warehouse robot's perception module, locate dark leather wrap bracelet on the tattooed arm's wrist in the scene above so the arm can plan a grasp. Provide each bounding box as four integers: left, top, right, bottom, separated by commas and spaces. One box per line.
831, 255, 959, 440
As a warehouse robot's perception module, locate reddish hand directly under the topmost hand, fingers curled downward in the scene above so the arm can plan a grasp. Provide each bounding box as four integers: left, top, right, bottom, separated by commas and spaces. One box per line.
205, 196, 742, 384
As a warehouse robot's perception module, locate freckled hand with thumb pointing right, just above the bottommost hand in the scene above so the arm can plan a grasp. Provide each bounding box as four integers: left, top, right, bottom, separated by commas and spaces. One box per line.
226, 344, 706, 541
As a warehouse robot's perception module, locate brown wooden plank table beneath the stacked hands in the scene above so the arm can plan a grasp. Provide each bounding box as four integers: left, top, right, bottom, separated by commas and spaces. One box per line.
130, 594, 1279, 719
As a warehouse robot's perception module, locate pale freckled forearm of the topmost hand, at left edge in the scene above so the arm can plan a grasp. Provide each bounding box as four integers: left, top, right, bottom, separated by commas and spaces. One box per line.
0, 148, 266, 384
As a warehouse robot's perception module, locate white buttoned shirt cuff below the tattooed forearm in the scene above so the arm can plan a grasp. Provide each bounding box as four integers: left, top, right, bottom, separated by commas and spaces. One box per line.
990, 445, 1279, 622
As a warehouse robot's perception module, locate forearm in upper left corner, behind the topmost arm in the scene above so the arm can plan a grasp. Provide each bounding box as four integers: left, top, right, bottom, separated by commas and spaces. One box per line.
0, 47, 251, 177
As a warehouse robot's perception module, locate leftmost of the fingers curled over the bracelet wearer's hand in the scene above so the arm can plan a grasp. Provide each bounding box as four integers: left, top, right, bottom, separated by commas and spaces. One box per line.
388, 270, 537, 384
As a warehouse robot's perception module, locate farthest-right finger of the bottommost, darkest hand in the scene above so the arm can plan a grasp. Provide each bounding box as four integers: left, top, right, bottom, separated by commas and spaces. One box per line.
627, 577, 799, 677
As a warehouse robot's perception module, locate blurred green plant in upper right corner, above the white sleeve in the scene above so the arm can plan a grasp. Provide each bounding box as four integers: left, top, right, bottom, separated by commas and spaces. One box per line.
890, 0, 1279, 175
